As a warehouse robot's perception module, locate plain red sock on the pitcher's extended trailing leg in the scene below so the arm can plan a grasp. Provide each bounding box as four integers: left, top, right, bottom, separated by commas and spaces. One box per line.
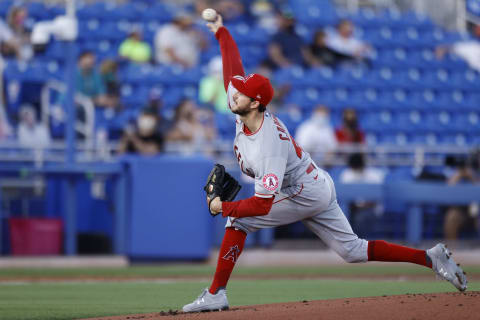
368, 240, 432, 268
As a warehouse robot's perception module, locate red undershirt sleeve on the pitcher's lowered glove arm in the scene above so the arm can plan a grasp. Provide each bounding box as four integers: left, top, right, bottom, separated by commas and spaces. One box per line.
222, 196, 275, 218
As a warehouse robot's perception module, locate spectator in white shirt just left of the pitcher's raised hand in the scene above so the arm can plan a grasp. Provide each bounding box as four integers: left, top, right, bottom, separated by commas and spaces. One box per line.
155, 12, 206, 68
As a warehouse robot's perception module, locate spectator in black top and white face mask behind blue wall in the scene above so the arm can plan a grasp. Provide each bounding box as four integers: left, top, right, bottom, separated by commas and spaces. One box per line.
118, 109, 164, 156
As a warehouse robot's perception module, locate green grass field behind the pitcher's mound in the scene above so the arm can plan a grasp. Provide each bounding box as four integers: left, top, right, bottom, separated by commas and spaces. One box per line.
0, 265, 480, 320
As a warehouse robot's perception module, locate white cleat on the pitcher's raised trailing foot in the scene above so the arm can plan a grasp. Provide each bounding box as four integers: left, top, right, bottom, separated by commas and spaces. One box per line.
427, 243, 467, 291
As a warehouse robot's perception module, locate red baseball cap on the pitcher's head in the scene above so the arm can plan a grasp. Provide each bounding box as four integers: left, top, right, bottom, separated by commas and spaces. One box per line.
230, 73, 273, 106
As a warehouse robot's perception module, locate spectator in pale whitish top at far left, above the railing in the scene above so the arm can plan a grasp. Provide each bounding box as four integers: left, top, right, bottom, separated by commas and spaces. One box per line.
17, 105, 51, 148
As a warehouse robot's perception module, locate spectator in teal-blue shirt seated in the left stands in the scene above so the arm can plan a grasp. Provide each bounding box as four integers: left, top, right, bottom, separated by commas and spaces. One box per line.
76, 51, 107, 107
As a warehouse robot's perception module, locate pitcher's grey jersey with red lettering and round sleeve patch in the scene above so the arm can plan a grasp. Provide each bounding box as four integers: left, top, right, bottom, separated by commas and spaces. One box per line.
228, 83, 316, 198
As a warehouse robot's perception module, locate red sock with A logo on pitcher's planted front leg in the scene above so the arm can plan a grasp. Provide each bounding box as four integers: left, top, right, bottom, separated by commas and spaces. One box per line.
209, 228, 247, 294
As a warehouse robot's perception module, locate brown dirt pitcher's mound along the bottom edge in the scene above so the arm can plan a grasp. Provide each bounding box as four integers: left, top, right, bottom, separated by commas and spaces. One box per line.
85, 291, 480, 320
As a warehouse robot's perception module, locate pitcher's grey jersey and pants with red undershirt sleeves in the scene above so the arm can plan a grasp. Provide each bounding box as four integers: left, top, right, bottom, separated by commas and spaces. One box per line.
215, 27, 368, 262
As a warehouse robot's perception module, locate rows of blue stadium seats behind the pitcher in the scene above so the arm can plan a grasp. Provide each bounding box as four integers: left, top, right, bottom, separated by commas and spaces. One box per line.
0, 0, 480, 150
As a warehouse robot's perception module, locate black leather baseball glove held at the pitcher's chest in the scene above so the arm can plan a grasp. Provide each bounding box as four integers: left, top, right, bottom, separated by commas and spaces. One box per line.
203, 163, 242, 216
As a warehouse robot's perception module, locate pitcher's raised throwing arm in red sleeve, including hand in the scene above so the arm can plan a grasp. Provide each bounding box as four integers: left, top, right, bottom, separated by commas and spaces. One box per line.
207, 14, 245, 91
